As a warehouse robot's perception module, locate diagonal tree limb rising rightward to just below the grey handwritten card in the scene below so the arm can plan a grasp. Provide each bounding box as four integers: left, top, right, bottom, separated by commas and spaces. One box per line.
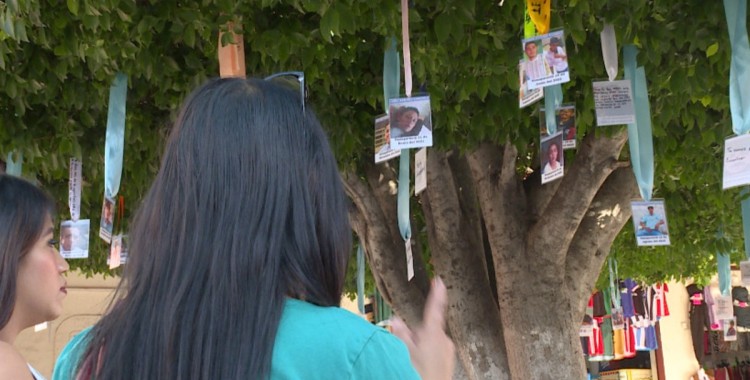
528, 130, 628, 268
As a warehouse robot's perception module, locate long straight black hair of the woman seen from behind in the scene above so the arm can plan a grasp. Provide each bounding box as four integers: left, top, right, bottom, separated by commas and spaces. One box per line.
79, 78, 351, 379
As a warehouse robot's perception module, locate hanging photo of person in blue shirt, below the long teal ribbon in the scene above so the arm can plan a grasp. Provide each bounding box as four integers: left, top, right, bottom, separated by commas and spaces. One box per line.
630, 199, 670, 246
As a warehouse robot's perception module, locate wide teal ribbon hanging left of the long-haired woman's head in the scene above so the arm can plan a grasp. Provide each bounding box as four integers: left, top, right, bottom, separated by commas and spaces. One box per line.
104, 73, 128, 198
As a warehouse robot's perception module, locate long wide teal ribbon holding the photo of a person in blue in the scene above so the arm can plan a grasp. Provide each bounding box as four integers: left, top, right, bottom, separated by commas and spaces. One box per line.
622, 45, 654, 201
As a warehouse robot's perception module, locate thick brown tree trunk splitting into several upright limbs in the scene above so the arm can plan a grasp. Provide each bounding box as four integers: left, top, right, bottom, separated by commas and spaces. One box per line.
343, 131, 637, 379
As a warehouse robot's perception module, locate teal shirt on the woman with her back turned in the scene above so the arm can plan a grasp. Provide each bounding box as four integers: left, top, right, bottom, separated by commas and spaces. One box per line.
52, 299, 420, 380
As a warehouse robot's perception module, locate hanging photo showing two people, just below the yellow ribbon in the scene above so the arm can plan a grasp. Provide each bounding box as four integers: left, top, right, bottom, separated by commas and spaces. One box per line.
521, 30, 570, 90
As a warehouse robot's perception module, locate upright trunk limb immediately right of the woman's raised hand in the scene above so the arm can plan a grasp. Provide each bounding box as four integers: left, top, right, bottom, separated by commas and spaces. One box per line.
422, 151, 508, 379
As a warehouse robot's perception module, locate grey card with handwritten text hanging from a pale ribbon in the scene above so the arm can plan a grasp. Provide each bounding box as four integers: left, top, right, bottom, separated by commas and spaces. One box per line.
592, 79, 635, 127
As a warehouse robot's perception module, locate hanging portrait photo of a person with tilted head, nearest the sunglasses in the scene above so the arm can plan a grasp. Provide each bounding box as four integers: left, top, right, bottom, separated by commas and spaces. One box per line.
388, 96, 432, 150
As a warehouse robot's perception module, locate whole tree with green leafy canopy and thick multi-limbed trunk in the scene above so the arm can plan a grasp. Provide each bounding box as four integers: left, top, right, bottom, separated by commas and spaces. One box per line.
0, 0, 743, 379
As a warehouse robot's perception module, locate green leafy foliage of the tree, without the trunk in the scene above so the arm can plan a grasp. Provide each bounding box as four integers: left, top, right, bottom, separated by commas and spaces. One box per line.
0, 0, 742, 286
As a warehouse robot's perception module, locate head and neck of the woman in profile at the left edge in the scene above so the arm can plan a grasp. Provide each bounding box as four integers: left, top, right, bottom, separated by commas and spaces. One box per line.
0, 174, 68, 379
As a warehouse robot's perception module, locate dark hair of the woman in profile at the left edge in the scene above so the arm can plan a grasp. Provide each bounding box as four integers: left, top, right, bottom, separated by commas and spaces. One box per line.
0, 174, 55, 329
